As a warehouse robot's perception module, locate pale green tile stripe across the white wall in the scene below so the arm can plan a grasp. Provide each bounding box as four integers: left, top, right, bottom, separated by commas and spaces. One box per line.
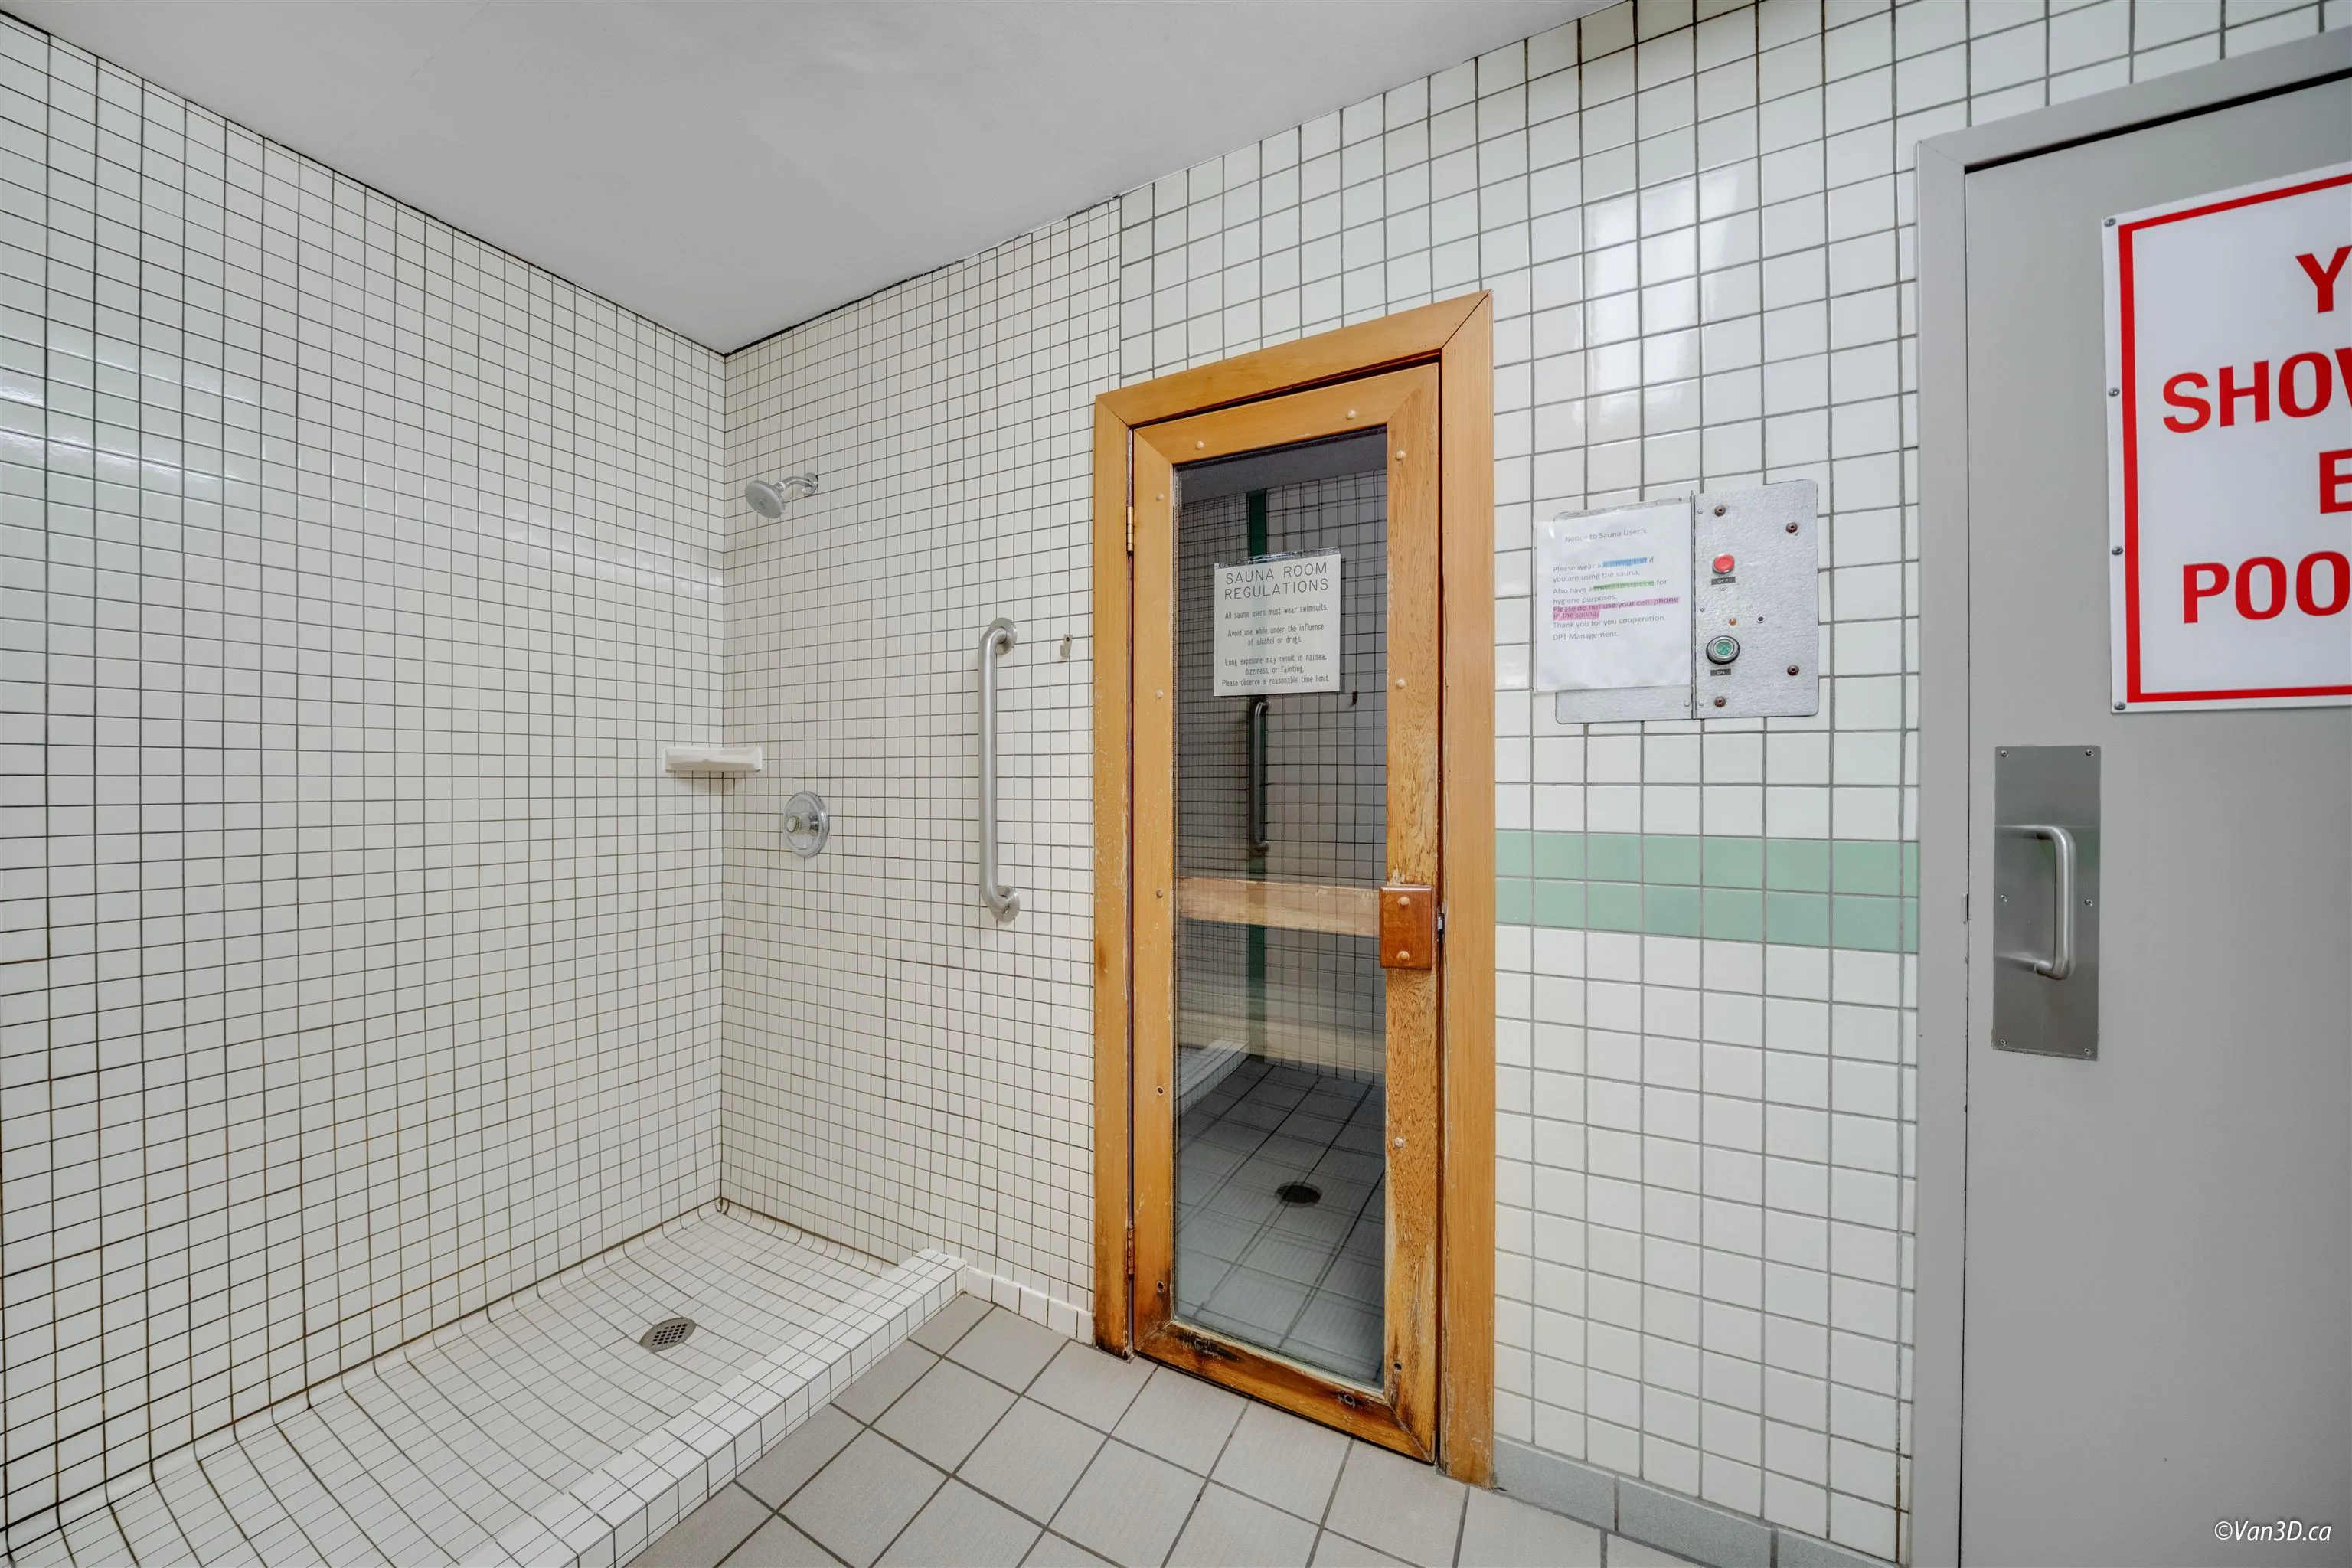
1496, 830, 1919, 952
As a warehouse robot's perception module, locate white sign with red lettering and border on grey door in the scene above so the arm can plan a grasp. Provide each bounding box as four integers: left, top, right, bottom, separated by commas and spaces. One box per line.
2105, 165, 2352, 712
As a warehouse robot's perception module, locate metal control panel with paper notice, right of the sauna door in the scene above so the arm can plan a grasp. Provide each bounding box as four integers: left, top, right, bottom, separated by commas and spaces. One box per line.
1534, 479, 1821, 724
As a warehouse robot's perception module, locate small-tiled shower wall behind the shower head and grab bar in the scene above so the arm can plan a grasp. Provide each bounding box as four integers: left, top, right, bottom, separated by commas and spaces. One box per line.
720, 207, 1117, 1328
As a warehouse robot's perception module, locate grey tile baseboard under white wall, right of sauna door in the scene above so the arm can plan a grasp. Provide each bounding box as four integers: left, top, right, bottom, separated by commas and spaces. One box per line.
1494, 1439, 1891, 1568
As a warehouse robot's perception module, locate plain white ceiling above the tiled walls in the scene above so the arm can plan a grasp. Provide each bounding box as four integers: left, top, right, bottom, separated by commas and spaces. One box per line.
32, 0, 1599, 348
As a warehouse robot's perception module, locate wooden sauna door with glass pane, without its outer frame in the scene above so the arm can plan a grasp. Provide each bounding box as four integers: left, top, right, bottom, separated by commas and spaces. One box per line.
1132, 364, 1444, 1458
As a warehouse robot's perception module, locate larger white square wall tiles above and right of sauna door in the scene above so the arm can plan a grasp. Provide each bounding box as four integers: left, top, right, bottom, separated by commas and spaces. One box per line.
1119, 0, 2352, 1557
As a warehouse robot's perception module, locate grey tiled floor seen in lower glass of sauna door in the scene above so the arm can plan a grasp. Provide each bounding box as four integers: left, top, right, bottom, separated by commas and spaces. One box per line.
1176, 1058, 1387, 1385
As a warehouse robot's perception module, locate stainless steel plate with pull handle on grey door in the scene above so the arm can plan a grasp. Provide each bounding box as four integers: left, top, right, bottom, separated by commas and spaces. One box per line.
1992, 745, 2100, 1060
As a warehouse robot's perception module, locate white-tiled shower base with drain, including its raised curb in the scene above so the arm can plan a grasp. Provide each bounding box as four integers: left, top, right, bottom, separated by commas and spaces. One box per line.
7, 1204, 955, 1568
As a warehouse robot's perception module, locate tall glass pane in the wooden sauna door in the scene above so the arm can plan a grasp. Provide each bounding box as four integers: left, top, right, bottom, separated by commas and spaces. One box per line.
1176, 430, 1387, 1387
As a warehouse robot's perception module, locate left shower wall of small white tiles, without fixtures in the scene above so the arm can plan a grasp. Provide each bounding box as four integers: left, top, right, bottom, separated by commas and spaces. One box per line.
0, 19, 722, 1535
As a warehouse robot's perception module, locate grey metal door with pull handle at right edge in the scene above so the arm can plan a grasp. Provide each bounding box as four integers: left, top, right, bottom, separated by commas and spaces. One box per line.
1959, 80, 2352, 1563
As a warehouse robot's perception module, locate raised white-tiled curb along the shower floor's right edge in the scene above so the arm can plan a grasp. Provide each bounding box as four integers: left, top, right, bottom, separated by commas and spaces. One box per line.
503, 1248, 965, 1568
